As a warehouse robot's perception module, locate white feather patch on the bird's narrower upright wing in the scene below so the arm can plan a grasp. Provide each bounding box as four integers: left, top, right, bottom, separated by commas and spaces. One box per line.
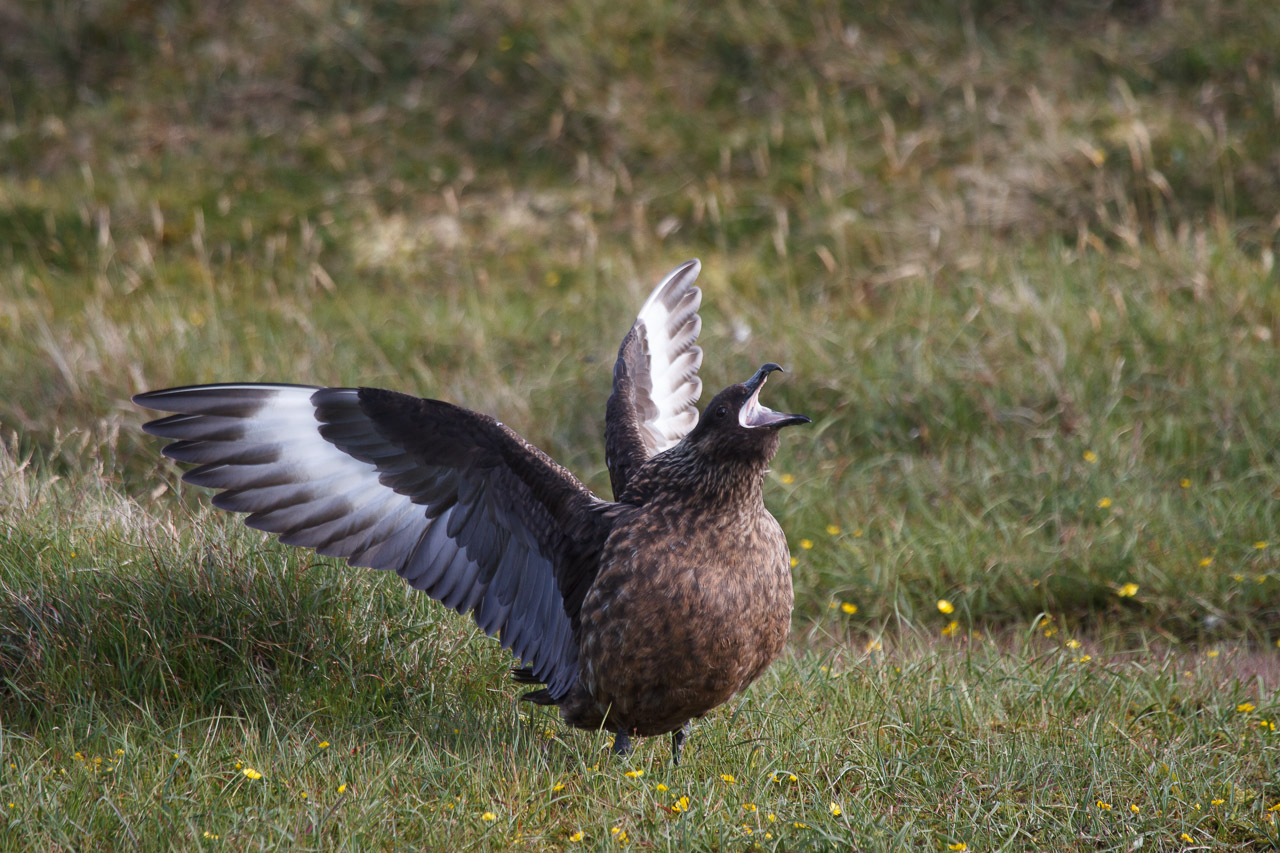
636, 260, 703, 455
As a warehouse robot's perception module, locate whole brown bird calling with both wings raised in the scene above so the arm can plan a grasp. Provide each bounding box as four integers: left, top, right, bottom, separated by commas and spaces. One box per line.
134, 261, 808, 762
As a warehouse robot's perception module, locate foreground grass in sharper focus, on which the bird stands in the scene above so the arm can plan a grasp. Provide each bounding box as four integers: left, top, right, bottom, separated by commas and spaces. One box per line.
0, 450, 1280, 849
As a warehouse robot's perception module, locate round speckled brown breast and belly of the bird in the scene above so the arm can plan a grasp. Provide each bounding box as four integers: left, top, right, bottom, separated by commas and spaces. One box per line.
579, 506, 794, 735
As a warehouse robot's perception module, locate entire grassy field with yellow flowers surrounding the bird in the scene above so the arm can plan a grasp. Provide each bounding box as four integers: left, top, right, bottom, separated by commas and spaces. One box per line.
0, 0, 1280, 850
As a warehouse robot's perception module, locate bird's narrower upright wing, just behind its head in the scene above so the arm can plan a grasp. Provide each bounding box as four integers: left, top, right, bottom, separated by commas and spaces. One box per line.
604, 260, 703, 497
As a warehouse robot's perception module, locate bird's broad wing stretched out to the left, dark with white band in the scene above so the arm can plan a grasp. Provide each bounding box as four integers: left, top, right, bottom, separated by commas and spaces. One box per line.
133, 384, 611, 698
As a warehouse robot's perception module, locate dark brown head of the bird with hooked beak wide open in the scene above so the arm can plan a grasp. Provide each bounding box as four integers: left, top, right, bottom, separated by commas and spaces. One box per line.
689, 361, 809, 462
